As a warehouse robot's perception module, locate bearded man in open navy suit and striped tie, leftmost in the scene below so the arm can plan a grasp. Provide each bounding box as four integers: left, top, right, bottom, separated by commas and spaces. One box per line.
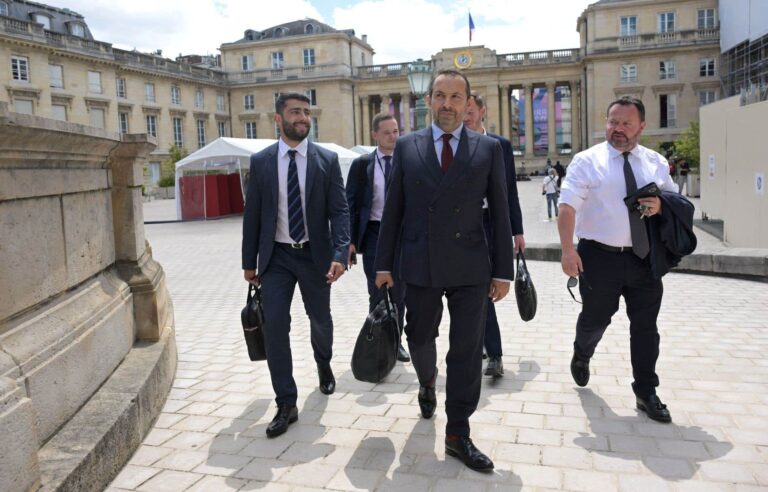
242, 93, 349, 437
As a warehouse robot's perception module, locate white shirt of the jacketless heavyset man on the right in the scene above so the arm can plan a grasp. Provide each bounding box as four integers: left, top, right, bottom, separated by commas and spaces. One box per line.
560, 141, 677, 247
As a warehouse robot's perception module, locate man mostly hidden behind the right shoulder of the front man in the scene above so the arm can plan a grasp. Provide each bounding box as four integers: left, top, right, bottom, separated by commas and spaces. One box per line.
464, 91, 525, 379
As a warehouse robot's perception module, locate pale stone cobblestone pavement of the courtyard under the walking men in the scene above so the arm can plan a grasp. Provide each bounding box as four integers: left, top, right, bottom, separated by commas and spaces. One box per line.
109, 183, 768, 492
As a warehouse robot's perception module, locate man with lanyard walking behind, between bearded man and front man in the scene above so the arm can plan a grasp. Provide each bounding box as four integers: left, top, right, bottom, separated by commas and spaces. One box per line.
347, 113, 411, 362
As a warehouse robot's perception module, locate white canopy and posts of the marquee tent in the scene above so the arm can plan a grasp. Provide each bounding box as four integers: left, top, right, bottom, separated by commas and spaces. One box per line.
176, 137, 359, 219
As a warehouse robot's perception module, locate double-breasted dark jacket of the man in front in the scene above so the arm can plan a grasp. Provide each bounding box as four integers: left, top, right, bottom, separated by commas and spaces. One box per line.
376, 127, 514, 287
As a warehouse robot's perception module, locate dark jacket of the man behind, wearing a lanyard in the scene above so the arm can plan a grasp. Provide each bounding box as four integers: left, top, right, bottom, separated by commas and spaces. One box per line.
347, 150, 376, 252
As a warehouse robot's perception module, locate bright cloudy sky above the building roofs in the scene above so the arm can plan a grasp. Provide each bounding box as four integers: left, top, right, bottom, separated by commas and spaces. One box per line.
58, 0, 596, 64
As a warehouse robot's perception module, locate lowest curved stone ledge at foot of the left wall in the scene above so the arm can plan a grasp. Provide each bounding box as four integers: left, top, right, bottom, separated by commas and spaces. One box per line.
38, 327, 177, 492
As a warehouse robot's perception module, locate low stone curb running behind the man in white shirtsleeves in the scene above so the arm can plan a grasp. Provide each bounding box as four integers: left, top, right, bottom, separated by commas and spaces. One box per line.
525, 243, 768, 282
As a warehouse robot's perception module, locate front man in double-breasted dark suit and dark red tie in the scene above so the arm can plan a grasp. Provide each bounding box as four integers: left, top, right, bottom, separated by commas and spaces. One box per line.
376, 70, 514, 471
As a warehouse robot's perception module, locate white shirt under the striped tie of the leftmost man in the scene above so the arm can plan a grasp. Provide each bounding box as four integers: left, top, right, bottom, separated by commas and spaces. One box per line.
275, 138, 309, 244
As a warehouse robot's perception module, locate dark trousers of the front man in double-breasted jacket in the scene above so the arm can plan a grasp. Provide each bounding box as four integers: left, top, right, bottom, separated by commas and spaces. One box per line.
405, 284, 489, 436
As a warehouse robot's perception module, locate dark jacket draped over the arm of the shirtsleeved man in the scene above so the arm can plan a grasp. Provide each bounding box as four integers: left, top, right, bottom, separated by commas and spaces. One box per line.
647, 191, 696, 279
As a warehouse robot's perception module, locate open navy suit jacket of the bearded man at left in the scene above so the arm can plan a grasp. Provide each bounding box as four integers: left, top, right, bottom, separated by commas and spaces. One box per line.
243, 142, 349, 275
